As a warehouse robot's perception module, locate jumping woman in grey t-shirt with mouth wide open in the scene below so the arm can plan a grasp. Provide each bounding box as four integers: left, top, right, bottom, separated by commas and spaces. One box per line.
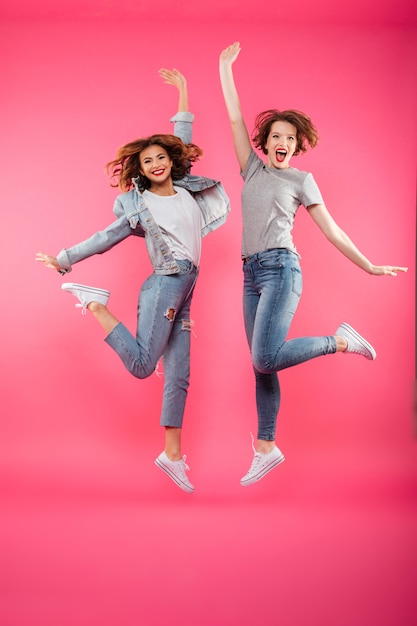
220, 43, 407, 486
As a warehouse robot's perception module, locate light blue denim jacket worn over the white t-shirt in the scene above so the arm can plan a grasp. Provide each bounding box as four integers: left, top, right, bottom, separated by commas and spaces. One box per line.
57, 112, 230, 274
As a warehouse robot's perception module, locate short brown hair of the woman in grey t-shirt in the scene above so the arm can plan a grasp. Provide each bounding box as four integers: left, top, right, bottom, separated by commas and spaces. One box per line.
252, 109, 318, 156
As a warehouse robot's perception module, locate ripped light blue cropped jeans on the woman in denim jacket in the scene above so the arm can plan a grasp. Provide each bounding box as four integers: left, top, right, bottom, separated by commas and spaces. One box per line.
105, 260, 198, 428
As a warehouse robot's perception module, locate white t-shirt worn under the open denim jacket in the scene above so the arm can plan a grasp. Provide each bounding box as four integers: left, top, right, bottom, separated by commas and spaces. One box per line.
143, 185, 202, 267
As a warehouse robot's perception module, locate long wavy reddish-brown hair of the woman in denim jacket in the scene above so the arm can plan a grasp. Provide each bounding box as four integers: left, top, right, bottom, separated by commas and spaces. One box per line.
106, 135, 203, 191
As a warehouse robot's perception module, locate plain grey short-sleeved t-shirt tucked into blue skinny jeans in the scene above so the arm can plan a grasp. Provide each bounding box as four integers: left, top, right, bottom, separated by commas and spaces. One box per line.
242, 150, 323, 258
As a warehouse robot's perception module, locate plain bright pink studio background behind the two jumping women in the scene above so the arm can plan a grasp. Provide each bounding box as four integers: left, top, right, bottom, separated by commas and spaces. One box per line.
0, 0, 417, 626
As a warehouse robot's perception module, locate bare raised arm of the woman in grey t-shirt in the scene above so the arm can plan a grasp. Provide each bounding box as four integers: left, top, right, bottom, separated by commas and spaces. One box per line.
219, 42, 251, 170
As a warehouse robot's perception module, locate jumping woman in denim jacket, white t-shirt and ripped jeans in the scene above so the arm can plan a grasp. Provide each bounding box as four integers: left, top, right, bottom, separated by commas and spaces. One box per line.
36, 69, 229, 493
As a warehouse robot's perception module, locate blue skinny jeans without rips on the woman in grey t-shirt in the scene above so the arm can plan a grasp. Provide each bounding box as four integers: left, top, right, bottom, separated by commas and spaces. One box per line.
243, 248, 336, 441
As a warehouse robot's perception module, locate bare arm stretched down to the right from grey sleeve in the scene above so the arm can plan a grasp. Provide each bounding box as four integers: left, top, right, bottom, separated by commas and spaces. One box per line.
308, 204, 408, 276
